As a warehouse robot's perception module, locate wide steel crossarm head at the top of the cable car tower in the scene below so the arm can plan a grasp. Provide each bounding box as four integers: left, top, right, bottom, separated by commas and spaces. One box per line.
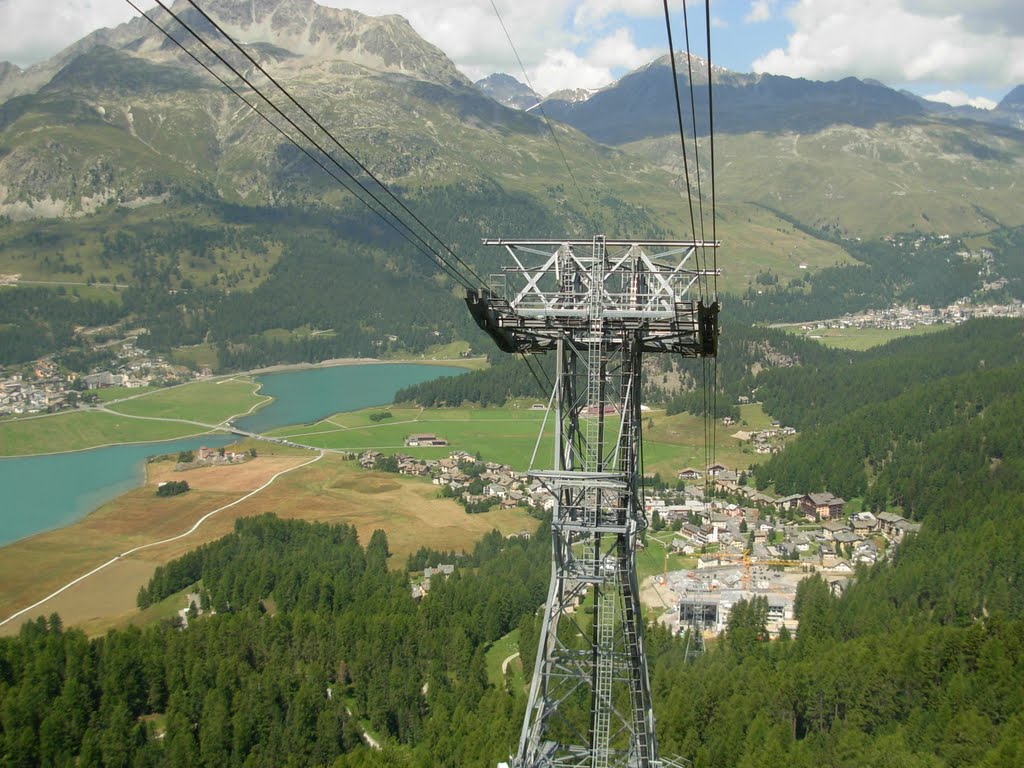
466, 237, 719, 356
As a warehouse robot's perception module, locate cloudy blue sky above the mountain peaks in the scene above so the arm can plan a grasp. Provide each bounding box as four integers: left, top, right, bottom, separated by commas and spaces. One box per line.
0, 0, 1024, 109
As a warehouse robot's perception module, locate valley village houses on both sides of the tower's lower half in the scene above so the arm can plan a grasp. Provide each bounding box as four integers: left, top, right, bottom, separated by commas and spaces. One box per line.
358, 438, 921, 637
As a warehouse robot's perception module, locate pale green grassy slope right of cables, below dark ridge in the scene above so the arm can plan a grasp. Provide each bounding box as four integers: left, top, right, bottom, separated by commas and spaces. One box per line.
624, 121, 1024, 239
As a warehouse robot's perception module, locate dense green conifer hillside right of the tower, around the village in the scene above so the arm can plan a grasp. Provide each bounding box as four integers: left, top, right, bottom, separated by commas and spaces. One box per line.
654, 322, 1024, 768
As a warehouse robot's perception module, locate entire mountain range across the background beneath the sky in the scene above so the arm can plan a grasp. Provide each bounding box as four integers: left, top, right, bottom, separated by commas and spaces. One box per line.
0, 0, 1024, 370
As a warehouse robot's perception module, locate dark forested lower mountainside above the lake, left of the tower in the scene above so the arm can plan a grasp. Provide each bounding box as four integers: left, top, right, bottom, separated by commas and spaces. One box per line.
0, 182, 589, 370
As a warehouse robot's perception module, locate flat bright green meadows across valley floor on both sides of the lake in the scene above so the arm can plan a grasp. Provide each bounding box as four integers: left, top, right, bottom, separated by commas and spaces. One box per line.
0, 376, 769, 479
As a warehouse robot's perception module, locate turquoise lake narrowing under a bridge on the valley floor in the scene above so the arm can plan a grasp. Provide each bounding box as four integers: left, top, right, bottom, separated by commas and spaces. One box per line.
0, 364, 465, 546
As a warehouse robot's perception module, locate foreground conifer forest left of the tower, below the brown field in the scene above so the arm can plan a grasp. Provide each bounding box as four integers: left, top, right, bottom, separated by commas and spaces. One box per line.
0, 515, 548, 767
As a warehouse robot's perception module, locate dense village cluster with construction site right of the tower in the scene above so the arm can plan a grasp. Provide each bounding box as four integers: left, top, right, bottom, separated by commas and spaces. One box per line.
645, 464, 921, 638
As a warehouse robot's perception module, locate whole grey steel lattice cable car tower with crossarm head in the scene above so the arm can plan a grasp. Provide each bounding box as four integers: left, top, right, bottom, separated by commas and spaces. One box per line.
466, 237, 718, 768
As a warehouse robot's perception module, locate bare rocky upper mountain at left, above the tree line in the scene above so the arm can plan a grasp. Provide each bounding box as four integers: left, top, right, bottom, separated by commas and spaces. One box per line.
0, 0, 573, 219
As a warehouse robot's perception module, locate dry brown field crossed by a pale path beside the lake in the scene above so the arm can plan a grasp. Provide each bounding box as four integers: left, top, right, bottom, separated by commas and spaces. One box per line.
0, 454, 536, 635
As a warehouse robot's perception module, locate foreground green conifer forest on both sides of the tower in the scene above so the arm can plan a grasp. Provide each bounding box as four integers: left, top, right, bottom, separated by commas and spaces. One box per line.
0, 321, 1024, 768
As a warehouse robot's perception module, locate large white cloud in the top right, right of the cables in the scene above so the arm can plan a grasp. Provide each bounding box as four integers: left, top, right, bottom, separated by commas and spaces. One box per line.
754, 0, 1024, 86
